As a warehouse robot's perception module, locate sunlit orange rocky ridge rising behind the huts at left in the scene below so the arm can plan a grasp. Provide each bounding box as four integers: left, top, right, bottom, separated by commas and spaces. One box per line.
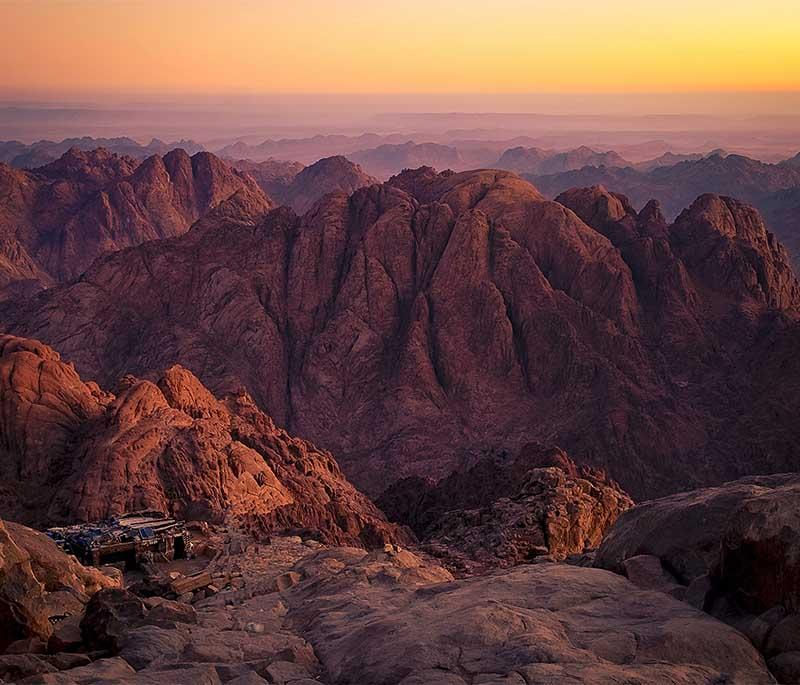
0, 336, 406, 545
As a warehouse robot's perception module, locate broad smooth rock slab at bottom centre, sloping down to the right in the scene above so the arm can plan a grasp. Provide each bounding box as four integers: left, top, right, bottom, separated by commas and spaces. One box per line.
287, 550, 770, 685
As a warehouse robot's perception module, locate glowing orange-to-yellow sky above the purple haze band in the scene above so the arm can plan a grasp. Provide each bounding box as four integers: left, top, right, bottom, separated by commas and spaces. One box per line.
0, 0, 800, 93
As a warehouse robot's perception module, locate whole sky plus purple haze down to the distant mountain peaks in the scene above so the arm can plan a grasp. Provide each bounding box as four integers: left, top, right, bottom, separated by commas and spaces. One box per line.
0, 0, 800, 160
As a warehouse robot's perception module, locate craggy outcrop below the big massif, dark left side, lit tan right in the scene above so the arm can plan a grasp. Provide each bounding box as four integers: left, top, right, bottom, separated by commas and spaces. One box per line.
377, 445, 633, 572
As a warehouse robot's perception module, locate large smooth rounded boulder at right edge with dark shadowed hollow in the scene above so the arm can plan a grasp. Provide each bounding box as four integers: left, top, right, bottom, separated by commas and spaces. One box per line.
595, 474, 800, 615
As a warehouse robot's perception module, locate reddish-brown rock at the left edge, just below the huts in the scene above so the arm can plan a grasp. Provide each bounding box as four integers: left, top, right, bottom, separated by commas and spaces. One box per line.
0, 521, 114, 653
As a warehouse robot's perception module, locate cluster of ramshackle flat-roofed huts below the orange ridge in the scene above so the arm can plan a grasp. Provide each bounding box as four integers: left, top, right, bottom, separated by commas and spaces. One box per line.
47, 511, 192, 568
